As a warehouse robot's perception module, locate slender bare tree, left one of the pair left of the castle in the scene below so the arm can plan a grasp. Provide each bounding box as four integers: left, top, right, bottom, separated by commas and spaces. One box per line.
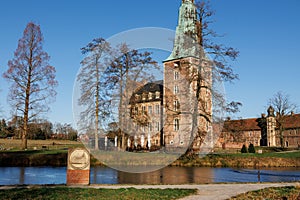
77, 38, 111, 150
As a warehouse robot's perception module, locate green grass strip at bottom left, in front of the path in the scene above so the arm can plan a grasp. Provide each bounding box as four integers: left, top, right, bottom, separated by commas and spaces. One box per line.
0, 187, 197, 200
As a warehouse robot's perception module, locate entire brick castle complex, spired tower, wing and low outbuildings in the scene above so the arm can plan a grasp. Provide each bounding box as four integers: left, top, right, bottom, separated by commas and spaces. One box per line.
121, 0, 300, 152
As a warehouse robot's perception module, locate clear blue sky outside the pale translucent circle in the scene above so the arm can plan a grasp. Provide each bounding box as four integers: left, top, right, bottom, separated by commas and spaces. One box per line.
0, 0, 300, 123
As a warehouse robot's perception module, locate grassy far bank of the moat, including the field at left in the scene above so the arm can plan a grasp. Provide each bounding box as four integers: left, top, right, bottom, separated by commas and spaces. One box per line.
0, 139, 300, 168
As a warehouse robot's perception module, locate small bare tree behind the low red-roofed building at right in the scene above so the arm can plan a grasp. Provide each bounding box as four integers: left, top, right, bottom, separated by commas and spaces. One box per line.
269, 91, 297, 147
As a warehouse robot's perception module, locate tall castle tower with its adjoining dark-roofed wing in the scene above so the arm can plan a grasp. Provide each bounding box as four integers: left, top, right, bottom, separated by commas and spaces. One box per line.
128, 0, 212, 150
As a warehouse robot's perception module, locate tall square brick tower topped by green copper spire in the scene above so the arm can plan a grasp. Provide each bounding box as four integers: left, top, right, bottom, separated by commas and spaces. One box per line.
163, 0, 212, 150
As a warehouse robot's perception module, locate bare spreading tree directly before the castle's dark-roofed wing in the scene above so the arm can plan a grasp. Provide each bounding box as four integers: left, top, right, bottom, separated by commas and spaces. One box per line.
103, 43, 159, 149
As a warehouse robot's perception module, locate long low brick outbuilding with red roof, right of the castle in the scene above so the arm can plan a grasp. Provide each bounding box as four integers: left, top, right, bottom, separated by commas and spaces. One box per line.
216, 114, 300, 148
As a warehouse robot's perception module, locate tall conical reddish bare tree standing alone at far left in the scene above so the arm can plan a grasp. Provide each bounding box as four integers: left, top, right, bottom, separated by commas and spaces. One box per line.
3, 22, 57, 149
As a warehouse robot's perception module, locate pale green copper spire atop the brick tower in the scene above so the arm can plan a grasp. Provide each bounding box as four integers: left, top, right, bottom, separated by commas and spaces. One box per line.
166, 0, 199, 61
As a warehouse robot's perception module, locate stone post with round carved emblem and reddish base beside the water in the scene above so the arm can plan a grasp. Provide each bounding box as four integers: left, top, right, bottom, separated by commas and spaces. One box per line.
67, 148, 90, 185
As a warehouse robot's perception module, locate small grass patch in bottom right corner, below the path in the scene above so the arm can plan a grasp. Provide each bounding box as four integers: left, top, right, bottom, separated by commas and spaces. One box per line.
230, 187, 300, 200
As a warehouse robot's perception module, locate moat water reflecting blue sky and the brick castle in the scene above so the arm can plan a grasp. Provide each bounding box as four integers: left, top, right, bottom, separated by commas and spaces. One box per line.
0, 167, 300, 185
